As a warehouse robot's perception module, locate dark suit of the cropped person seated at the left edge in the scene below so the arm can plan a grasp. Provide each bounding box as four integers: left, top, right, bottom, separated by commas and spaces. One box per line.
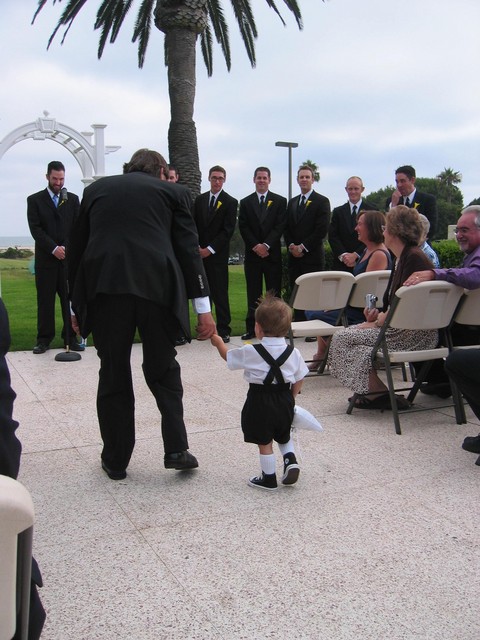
0, 298, 45, 640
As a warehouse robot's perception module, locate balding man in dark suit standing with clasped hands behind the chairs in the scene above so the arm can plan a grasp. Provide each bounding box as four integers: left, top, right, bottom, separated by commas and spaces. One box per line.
328, 176, 377, 273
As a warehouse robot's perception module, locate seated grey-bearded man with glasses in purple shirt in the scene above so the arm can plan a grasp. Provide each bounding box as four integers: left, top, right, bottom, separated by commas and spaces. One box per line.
403, 205, 480, 398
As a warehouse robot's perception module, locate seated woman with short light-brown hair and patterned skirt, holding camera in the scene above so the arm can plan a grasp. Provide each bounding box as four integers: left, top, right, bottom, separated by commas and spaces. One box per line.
328, 205, 438, 409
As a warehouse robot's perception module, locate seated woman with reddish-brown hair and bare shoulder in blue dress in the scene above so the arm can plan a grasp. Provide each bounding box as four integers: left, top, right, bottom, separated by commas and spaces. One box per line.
305, 210, 392, 371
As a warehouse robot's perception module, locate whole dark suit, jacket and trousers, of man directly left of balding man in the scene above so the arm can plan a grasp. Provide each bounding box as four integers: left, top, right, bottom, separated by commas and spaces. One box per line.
285, 191, 330, 287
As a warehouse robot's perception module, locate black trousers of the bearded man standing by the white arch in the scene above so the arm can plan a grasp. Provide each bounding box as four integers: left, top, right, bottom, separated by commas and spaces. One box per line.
35, 260, 74, 344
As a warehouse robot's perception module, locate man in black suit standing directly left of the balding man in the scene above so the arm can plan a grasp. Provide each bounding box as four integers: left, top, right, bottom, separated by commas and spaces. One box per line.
285, 165, 330, 320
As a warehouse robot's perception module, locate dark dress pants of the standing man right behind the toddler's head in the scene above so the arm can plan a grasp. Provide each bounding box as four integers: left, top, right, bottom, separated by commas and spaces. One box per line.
243, 258, 282, 333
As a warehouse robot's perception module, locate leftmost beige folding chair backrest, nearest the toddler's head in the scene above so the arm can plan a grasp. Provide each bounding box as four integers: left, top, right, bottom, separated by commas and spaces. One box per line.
290, 271, 355, 311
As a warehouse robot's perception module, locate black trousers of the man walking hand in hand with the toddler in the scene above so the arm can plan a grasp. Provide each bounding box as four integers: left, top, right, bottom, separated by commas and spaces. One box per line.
89, 295, 188, 471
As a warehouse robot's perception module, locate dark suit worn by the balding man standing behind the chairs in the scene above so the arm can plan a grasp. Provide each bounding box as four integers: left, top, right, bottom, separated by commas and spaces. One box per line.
328, 199, 377, 273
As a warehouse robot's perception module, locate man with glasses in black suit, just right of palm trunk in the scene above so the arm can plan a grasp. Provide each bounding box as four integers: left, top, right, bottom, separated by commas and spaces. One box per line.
193, 165, 238, 342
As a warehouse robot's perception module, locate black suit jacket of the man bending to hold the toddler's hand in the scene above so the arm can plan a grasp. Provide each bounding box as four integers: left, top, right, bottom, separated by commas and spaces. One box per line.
69, 172, 210, 337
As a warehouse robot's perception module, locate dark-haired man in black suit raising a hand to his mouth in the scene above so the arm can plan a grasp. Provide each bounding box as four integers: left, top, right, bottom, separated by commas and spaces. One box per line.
385, 164, 438, 240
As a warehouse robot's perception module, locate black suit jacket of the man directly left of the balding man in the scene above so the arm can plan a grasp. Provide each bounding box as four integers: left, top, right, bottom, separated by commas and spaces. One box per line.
285, 191, 330, 264
